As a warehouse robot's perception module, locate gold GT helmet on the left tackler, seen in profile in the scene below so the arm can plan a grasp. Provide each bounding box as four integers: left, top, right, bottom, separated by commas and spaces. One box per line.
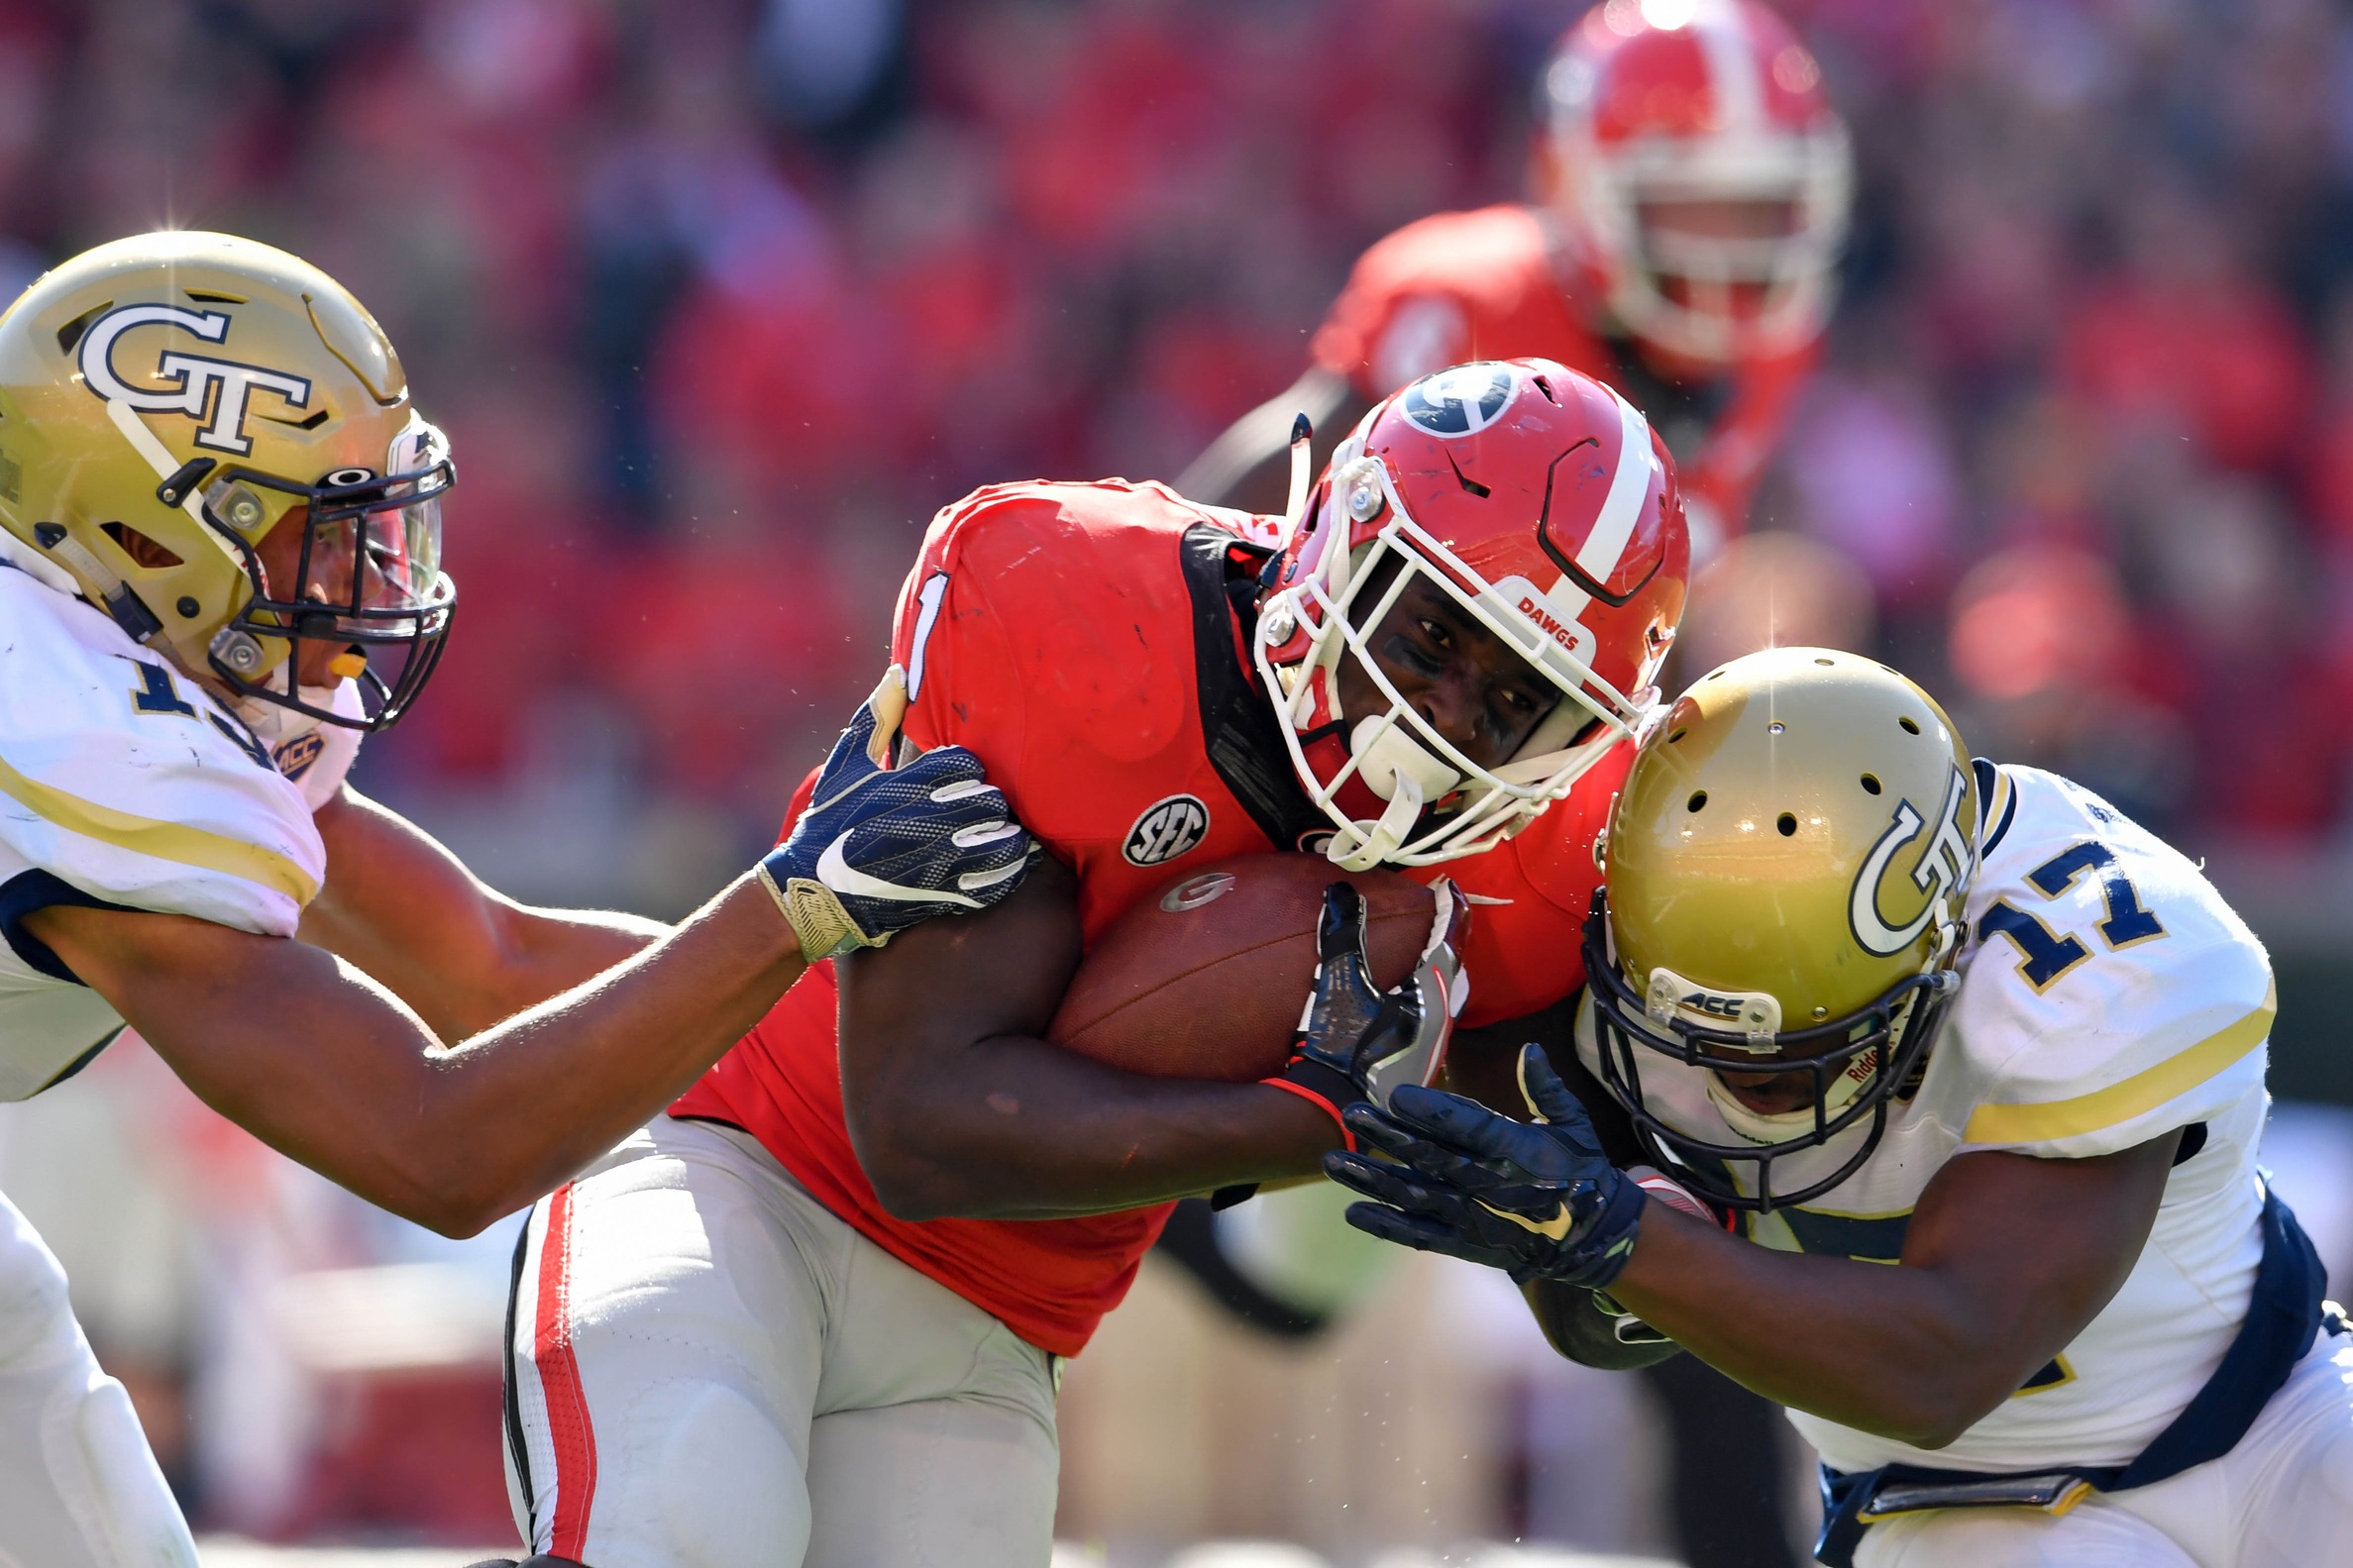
0, 231, 457, 729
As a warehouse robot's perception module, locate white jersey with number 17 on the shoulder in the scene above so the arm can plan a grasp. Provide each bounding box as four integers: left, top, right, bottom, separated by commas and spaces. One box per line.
1579, 764, 2273, 1472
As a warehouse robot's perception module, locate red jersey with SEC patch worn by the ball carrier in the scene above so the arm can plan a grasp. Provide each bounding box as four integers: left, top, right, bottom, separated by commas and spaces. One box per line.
673, 479, 1633, 1356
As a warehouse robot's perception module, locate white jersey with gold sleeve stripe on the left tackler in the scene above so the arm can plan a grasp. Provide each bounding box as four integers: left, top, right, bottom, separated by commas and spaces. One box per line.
0, 552, 358, 1100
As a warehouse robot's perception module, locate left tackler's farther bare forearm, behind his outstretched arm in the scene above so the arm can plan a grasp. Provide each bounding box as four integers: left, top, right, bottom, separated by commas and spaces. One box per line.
296, 785, 669, 1039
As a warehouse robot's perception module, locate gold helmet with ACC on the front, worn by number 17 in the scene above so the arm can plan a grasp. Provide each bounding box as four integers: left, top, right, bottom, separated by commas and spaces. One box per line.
1586, 649, 1979, 1210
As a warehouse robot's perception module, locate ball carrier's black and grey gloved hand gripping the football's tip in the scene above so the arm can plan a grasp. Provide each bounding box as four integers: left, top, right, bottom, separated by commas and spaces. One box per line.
1282, 882, 1470, 1126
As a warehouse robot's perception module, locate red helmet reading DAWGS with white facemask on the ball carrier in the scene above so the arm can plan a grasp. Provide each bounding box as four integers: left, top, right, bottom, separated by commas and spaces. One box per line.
1254, 360, 1692, 870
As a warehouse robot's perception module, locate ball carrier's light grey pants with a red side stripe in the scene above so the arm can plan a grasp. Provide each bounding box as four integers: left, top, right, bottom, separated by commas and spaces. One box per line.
508, 1116, 1059, 1568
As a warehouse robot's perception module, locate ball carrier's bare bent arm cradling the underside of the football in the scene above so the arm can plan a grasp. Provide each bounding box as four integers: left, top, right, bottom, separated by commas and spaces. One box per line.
840, 861, 1338, 1220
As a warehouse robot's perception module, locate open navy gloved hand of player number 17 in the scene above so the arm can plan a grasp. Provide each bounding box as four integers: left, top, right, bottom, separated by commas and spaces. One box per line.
1325, 1046, 1645, 1291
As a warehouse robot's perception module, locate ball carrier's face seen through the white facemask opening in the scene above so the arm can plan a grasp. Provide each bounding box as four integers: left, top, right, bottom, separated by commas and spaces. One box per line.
1338, 575, 1560, 769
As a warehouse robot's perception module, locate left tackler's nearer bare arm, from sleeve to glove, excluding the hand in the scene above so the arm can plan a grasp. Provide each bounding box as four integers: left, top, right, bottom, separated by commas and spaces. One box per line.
26, 877, 804, 1236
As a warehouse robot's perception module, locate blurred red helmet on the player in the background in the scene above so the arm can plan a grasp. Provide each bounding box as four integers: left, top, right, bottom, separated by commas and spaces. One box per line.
1546, 0, 1855, 365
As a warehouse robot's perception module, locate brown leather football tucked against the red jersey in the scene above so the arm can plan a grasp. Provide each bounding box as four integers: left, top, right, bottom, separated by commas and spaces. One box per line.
1047, 854, 1436, 1084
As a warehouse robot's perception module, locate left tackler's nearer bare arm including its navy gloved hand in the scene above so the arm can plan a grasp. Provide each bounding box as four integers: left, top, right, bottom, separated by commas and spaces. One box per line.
24, 670, 1026, 1234
